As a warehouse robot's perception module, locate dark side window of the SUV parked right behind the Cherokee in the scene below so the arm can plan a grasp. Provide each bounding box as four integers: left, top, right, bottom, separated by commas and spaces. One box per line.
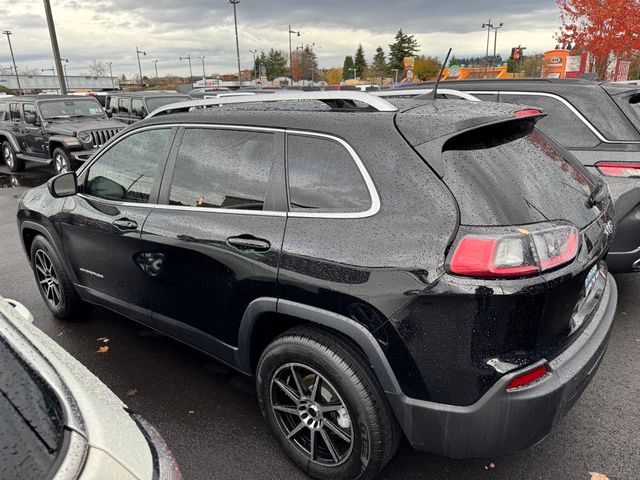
500, 92, 600, 148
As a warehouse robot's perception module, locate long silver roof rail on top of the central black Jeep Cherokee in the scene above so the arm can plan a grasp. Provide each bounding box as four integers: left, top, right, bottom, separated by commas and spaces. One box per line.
147, 90, 398, 118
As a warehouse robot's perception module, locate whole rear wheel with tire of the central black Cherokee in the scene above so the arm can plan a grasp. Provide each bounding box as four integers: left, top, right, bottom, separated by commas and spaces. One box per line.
256, 327, 401, 480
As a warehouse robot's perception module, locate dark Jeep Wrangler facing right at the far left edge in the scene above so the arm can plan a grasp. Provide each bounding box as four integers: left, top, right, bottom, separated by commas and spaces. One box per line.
0, 95, 126, 173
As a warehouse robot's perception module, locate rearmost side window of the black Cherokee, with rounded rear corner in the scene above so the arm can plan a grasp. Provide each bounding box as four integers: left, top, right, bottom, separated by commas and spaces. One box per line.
287, 135, 371, 212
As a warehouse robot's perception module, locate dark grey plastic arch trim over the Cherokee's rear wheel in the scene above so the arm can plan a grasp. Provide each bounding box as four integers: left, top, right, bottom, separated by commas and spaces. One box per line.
235, 298, 402, 394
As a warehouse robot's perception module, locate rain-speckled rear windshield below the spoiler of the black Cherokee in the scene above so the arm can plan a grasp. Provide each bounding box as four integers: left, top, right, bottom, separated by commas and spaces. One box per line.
443, 120, 598, 228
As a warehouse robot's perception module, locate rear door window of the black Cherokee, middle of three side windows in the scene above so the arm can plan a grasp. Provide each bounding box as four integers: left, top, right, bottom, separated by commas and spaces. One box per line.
169, 128, 275, 210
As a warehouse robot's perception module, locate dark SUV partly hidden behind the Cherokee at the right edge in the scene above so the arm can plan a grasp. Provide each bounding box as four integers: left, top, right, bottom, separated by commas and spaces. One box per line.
413, 79, 640, 272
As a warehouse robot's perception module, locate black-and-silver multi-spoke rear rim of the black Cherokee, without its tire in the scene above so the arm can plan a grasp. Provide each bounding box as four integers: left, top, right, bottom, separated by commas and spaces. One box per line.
271, 363, 354, 467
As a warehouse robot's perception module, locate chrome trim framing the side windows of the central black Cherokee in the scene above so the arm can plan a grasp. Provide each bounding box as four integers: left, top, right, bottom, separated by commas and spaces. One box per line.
77, 123, 381, 219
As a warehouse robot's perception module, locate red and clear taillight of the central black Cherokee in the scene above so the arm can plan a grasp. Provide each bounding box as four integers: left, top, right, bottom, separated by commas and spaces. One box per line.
448, 223, 579, 278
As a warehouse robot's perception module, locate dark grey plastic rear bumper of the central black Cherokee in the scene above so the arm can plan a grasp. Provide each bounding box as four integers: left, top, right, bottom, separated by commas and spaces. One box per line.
387, 275, 618, 458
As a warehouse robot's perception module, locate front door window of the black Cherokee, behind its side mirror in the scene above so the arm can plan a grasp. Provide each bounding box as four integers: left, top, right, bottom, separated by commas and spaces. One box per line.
84, 128, 171, 203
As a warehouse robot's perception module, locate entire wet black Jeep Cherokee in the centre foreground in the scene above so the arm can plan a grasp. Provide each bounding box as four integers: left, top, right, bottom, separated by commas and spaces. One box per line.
18, 92, 617, 479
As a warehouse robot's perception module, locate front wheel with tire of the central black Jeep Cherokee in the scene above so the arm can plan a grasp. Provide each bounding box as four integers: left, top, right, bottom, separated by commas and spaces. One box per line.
30, 235, 83, 319
